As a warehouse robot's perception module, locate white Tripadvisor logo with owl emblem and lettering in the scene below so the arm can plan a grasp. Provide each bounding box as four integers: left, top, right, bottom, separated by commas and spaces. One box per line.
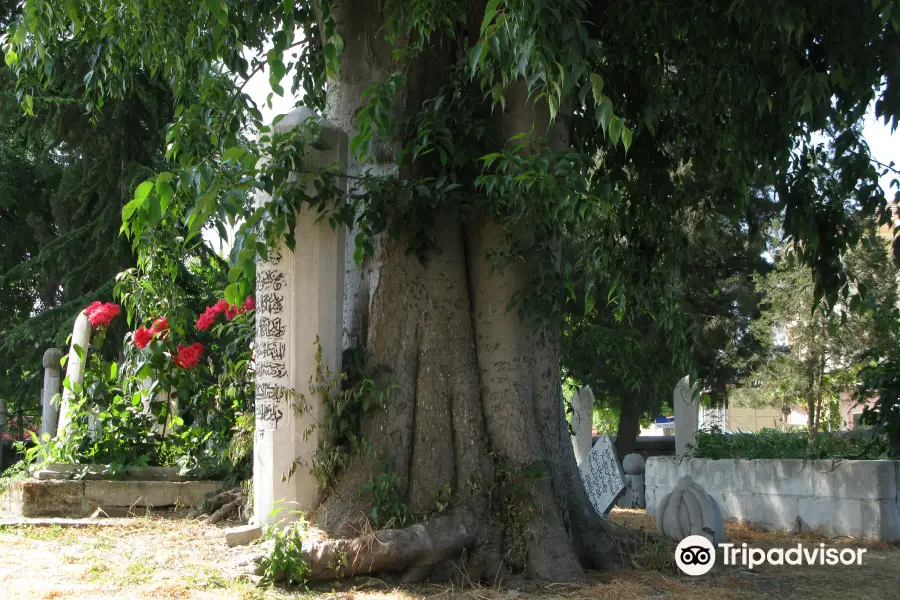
675, 535, 866, 577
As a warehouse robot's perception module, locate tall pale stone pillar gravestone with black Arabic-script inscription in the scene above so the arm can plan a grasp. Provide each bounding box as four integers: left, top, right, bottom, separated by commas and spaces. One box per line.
253, 108, 348, 525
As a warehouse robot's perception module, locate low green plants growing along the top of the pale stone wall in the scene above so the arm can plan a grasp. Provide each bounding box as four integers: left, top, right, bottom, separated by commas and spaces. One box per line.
691, 429, 885, 460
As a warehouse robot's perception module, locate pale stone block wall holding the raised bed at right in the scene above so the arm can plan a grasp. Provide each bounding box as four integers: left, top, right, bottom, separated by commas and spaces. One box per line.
645, 456, 900, 541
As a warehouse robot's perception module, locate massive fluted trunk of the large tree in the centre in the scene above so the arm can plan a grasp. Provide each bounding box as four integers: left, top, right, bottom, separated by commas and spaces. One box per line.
306, 0, 612, 583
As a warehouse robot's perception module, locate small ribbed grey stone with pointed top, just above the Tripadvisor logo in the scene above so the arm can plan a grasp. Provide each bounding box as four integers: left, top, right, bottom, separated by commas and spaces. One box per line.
656, 475, 725, 544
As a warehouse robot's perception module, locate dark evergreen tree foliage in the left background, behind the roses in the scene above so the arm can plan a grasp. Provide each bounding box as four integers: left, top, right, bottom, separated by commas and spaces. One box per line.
0, 0, 243, 434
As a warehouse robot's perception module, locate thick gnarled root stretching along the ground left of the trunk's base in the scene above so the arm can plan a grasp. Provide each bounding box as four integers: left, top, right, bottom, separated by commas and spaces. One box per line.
303, 508, 479, 581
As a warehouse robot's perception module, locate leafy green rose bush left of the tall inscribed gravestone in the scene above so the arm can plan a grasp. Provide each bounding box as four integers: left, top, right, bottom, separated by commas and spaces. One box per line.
24, 292, 254, 479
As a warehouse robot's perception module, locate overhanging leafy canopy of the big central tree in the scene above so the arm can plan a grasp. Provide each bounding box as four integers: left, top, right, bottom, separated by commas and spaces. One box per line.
8, 0, 898, 342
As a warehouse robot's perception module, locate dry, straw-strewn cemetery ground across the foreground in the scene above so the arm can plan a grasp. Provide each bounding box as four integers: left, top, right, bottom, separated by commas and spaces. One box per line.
0, 509, 900, 600
